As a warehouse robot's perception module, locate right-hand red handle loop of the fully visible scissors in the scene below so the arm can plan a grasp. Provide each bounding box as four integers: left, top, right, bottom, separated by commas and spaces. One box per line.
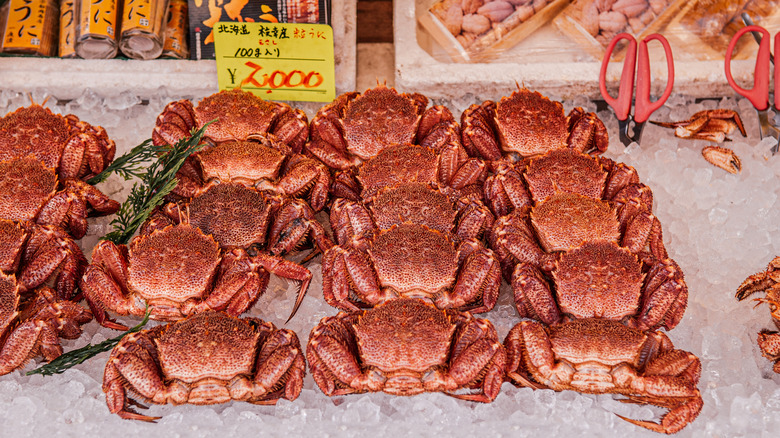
634, 33, 674, 123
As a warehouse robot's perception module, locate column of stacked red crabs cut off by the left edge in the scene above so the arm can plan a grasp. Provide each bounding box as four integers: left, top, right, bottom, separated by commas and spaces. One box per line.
0, 104, 119, 375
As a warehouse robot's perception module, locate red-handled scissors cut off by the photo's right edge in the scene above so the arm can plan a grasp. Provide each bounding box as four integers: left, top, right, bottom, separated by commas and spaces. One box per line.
726, 25, 780, 153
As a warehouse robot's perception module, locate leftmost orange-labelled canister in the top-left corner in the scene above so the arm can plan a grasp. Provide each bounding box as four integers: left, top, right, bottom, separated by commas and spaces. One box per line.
2, 0, 59, 56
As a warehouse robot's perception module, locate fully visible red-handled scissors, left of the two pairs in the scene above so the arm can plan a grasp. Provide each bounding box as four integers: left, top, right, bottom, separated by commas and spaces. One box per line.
599, 32, 674, 146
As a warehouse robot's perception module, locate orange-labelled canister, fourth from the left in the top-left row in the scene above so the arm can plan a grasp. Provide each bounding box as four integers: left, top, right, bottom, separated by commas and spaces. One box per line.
119, 0, 168, 59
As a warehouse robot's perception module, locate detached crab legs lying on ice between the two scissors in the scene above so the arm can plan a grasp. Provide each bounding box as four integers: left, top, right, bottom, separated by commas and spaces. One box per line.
650, 109, 747, 143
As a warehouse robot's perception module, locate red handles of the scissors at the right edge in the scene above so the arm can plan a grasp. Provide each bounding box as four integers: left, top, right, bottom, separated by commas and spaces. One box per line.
726, 25, 778, 111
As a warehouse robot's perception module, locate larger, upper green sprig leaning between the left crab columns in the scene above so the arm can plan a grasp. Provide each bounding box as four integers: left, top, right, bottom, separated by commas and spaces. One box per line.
103, 122, 211, 244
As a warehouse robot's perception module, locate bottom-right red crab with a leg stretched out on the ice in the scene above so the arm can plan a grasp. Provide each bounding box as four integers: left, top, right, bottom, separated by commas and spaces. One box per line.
504, 318, 703, 434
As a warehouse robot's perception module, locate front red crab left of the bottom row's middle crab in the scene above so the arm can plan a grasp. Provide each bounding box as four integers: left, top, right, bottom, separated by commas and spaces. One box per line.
103, 312, 306, 422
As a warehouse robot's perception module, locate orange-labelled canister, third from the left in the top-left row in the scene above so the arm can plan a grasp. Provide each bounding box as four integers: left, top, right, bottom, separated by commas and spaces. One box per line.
76, 0, 119, 59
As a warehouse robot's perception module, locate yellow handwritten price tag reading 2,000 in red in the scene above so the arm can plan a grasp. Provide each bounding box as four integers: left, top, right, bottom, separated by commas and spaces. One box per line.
214, 22, 336, 102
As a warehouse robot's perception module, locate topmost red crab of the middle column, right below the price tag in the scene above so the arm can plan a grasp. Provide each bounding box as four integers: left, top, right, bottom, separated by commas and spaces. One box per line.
306, 84, 459, 170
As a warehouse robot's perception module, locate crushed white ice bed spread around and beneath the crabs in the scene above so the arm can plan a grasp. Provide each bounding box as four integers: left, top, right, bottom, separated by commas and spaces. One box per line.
0, 89, 780, 437
